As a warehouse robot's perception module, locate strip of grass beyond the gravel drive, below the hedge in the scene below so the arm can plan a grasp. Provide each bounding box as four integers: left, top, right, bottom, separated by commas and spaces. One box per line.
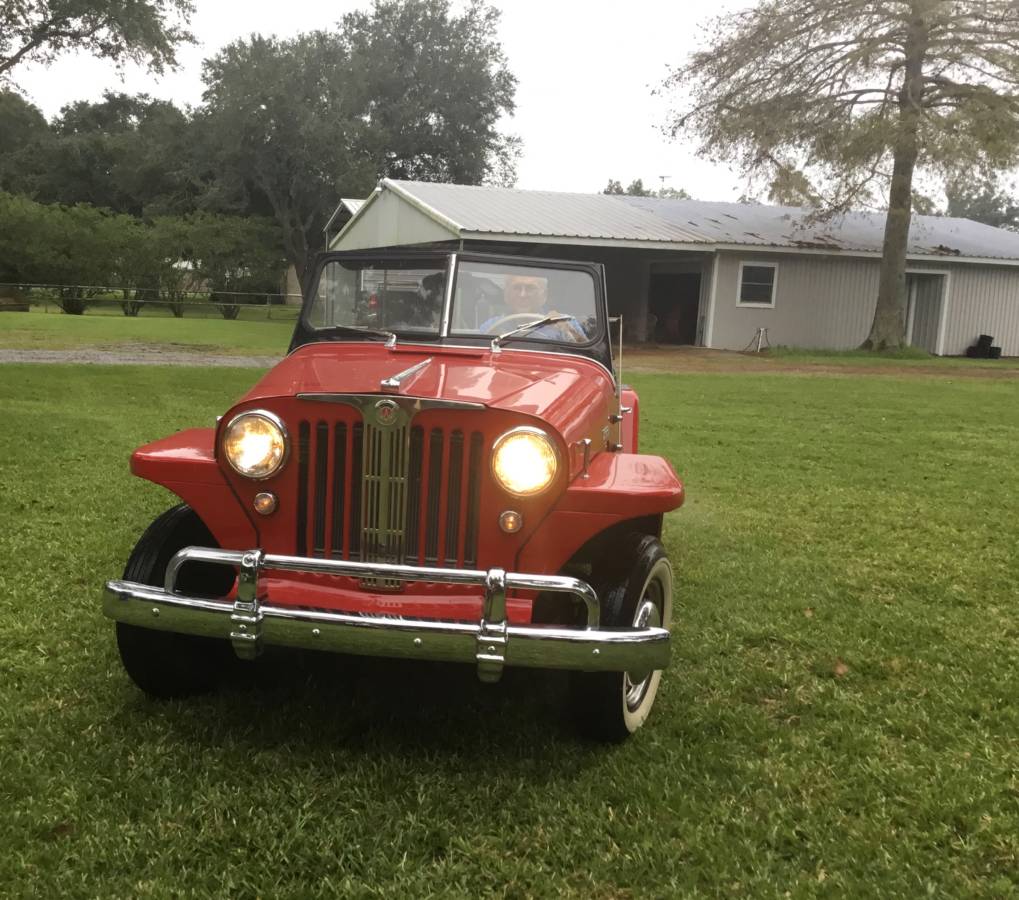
0, 309, 294, 356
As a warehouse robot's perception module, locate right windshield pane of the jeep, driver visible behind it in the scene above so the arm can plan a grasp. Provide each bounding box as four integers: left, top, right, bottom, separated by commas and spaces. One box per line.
449, 261, 598, 343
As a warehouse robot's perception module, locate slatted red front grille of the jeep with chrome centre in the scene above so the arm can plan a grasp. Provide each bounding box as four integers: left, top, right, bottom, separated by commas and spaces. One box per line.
296, 416, 484, 587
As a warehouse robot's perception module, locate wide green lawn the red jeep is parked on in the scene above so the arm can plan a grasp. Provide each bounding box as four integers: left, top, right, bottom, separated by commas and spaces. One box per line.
0, 362, 1019, 898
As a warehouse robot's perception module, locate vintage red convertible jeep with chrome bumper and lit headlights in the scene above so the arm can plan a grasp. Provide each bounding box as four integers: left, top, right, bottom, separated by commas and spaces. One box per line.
103, 252, 683, 739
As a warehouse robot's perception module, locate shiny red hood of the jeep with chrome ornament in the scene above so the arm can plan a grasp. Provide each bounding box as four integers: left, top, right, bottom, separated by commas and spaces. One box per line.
243, 342, 613, 435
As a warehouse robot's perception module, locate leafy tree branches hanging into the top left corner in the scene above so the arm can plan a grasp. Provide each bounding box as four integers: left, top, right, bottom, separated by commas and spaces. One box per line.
0, 0, 194, 78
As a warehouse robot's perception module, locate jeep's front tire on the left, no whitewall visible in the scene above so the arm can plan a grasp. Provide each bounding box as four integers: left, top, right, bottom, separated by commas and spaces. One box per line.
116, 505, 233, 699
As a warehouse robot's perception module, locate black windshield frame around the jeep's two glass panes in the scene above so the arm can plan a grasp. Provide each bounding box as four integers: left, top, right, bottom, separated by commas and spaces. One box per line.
290, 248, 614, 377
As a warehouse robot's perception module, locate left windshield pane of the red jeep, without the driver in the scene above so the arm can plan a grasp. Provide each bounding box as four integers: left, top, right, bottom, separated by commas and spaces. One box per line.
306, 259, 446, 335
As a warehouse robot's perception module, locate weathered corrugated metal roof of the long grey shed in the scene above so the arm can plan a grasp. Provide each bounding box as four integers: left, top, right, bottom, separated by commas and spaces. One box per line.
382, 180, 1019, 260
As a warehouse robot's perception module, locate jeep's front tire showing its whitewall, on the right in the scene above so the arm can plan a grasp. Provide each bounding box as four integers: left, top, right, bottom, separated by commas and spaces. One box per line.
570, 534, 673, 742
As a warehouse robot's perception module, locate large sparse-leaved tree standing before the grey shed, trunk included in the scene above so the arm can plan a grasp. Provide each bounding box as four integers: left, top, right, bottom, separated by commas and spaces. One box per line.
666, 0, 1019, 350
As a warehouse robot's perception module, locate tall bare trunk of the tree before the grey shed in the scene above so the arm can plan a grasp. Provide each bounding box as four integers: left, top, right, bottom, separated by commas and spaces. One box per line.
862, 15, 926, 351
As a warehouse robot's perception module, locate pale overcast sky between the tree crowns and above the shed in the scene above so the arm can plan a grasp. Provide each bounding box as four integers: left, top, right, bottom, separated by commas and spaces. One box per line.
13, 0, 746, 200
